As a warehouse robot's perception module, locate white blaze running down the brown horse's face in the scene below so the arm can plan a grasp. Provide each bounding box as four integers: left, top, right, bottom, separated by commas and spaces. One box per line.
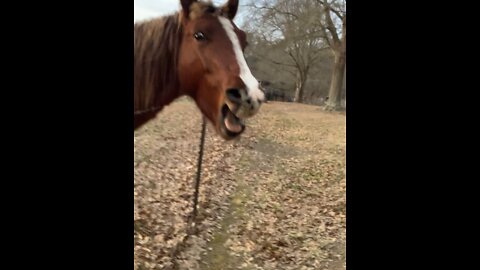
218, 17, 265, 101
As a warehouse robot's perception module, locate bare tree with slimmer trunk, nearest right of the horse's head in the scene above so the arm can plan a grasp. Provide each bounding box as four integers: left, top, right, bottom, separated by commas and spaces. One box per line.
246, 0, 328, 102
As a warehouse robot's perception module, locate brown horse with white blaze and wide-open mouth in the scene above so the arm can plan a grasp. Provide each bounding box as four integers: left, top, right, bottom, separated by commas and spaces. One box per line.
134, 0, 265, 140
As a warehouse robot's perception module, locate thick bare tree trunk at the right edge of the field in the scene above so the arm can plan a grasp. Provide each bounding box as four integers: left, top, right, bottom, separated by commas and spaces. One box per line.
325, 53, 346, 111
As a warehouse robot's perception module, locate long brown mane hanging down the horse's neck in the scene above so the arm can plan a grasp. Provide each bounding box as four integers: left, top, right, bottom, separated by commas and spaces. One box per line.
133, 13, 182, 112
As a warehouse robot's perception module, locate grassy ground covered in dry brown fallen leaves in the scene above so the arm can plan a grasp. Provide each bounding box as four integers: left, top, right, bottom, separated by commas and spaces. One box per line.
134, 99, 346, 270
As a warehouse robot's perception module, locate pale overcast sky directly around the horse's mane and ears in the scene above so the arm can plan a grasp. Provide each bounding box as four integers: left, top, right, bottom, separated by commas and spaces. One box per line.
133, 0, 248, 25
